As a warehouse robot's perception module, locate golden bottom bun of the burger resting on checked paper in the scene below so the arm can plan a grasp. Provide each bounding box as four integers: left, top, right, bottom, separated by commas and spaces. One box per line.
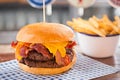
18, 53, 76, 75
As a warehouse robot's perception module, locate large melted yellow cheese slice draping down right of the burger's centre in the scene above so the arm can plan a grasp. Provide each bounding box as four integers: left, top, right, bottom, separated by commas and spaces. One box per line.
43, 42, 68, 57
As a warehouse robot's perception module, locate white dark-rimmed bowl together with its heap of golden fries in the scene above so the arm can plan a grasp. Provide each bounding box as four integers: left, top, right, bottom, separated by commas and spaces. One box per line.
67, 15, 120, 58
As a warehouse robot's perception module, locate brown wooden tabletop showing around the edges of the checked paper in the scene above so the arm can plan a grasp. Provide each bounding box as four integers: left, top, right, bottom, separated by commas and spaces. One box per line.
0, 51, 120, 80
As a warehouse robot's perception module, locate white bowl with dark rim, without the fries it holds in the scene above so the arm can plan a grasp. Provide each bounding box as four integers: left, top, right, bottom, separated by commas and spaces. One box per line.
77, 33, 119, 58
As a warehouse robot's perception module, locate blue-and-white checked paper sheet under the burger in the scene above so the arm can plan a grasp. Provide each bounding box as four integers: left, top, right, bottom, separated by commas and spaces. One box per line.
0, 53, 118, 80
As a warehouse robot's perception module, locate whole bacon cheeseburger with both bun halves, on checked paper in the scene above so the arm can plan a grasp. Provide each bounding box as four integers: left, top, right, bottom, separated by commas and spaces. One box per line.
11, 23, 76, 75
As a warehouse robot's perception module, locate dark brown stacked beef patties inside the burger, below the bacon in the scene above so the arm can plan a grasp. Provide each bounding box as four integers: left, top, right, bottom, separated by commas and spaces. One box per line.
20, 49, 74, 68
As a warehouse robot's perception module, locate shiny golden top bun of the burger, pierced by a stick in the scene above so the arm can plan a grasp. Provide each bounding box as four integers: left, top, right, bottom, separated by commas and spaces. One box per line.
16, 22, 73, 43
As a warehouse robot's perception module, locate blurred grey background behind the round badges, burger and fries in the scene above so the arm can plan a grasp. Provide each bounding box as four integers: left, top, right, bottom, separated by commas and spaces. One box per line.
0, 0, 120, 44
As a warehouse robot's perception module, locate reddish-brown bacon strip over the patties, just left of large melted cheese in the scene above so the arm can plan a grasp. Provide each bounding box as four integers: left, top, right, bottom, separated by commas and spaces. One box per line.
30, 44, 51, 59
